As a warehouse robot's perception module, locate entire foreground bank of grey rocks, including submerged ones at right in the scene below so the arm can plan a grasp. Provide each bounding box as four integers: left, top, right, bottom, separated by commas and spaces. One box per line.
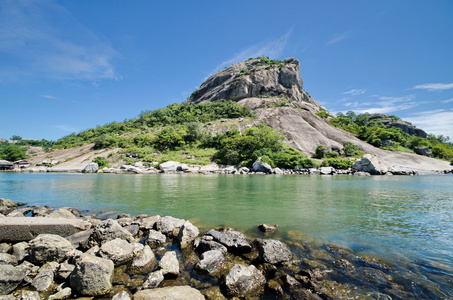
0, 199, 442, 300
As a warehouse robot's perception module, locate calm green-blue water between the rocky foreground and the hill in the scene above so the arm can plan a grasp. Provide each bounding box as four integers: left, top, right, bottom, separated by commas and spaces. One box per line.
0, 173, 453, 298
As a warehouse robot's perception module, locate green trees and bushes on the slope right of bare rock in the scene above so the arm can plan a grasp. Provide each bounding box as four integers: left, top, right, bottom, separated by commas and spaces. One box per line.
328, 111, 453, 160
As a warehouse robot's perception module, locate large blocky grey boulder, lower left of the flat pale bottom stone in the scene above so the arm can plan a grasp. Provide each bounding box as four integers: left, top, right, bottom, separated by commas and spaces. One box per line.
69, 254, 114, 296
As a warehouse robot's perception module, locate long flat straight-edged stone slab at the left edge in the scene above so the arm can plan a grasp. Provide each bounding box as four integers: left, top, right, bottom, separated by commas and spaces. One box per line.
0, 217, 91, 242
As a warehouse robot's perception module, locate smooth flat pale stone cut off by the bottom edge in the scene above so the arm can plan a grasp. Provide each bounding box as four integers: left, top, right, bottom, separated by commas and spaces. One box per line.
134, 286, 205, 300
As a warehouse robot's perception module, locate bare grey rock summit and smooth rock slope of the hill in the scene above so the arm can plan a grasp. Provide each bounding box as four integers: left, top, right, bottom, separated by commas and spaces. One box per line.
188, 58, 451, 172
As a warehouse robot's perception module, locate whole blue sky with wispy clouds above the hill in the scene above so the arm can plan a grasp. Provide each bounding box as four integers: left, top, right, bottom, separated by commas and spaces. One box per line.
0, 0, 453, 140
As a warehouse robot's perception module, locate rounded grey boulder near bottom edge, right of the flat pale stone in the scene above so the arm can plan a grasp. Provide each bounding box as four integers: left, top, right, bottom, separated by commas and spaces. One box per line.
225, 264, 266, 297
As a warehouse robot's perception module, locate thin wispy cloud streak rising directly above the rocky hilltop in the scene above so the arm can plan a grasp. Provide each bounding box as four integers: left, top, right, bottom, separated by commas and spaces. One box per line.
208, 28, 293, 76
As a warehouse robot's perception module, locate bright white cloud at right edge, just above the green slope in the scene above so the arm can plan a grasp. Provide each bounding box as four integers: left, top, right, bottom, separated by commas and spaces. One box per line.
405, 109, 453, 137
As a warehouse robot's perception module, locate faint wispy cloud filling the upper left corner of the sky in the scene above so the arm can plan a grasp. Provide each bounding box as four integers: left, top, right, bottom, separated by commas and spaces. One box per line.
0, 0, 120, 81
